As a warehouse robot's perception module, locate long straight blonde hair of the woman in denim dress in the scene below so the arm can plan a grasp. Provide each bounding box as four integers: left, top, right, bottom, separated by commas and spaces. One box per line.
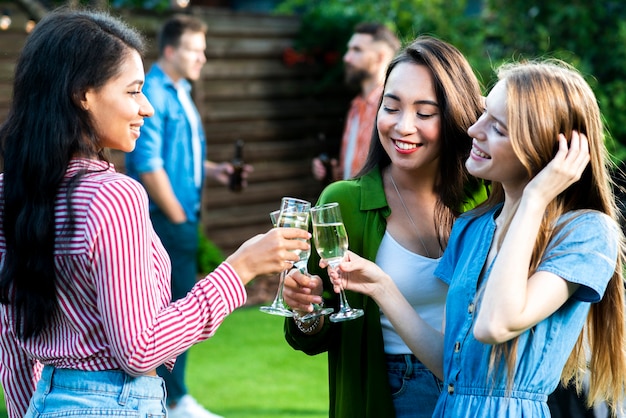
476, 59, 626, 411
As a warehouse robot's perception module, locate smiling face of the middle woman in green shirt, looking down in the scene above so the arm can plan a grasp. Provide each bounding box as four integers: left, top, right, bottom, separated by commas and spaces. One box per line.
377, 62, 441, 173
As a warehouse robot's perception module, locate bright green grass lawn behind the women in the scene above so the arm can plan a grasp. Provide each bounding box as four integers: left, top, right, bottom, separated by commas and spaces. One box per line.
0, 307, 328, 418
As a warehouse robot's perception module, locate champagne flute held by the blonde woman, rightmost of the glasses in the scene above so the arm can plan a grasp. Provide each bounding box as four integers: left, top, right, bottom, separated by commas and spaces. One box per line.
311, 202, 364, 322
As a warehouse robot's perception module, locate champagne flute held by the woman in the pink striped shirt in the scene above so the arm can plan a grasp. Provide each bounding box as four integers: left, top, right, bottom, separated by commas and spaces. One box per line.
259, 197, 311, 317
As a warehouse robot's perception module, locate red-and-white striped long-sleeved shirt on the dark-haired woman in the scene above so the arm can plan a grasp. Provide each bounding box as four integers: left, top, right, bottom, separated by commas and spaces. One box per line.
0, 160, 246, 418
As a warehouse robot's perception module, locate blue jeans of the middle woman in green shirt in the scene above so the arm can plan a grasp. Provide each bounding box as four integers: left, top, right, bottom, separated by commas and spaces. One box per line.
386, 354, 443, 418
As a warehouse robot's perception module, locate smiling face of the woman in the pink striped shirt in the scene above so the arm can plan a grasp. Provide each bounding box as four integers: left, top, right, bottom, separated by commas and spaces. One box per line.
82, 51, 154, 152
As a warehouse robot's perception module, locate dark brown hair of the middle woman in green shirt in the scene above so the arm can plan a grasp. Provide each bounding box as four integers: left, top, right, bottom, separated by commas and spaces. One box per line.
357, 36, 484, 248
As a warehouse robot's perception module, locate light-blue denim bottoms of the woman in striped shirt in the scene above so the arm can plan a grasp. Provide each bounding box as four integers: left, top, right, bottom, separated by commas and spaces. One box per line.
25, 366, 165, 418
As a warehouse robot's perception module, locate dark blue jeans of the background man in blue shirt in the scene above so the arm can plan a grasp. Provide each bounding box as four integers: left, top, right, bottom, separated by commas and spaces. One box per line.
150, 211, 198, 404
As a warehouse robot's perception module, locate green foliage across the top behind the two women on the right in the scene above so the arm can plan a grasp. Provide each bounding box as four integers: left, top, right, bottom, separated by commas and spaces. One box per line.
277, 0, 626, 160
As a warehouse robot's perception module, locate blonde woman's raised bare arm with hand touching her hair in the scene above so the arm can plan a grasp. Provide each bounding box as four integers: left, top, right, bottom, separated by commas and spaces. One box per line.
474, 131, 589, 343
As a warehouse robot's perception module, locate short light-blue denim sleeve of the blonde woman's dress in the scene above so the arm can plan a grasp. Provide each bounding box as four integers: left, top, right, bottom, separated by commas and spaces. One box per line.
537, 211, 620, 302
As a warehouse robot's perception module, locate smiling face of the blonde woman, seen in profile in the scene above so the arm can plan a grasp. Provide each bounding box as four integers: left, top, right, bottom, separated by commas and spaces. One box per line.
465, 80, 528, 190
